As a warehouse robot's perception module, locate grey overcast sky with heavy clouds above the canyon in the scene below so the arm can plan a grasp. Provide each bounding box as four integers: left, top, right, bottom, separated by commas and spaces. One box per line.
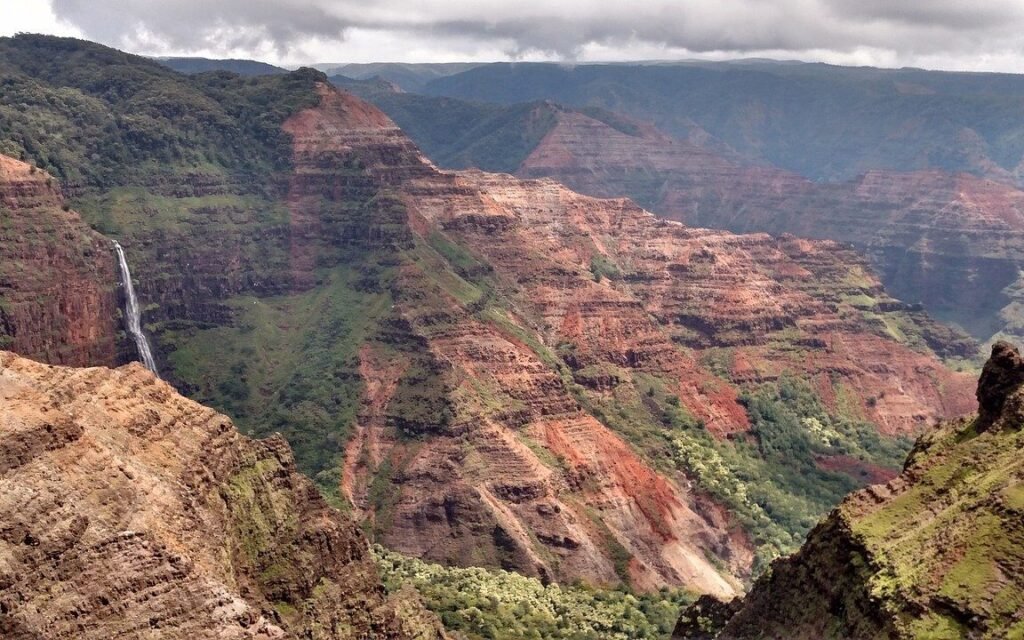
6, 0, 1024, 73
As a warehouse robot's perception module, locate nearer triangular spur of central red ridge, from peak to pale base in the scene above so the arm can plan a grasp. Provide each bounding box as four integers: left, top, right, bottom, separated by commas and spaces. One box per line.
287, 86, 749, 594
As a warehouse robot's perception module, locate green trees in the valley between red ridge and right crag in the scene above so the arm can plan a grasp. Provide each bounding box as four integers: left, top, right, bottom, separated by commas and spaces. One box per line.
684, 377, 910, 570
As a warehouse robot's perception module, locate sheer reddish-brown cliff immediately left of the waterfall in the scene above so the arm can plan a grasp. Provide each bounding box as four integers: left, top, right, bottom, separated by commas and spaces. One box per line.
0, 156, 118, 365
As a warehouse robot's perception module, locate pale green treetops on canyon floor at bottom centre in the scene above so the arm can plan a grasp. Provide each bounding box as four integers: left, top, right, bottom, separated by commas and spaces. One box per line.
374, 547, 693, 640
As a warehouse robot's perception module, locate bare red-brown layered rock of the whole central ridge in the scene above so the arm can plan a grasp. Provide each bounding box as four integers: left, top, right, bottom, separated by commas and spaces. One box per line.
286, 87, 974, 594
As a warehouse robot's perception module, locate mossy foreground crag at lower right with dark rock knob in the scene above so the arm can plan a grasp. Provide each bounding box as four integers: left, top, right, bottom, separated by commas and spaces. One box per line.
674, 342, 1024, 640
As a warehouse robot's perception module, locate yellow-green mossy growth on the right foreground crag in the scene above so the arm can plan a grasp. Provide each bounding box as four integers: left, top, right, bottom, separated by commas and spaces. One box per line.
850, 413, 1024, 638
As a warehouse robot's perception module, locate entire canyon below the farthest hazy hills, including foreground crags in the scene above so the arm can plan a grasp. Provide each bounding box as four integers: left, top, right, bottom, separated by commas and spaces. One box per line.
0, 35, 1024, 640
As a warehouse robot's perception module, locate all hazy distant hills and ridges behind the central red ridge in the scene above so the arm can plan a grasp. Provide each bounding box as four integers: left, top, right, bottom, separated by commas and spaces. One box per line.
348, 65, 1024, 344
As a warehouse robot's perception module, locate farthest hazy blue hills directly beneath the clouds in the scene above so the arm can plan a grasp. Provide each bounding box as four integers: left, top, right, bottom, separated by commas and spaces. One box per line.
424, 61, 1024, 182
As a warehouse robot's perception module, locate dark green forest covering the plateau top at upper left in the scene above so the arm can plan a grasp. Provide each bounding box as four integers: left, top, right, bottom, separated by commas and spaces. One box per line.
0, 35, 326, 190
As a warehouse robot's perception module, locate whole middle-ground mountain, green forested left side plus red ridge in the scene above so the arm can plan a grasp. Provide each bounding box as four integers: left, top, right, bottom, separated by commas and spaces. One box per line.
0, 37, 975, 597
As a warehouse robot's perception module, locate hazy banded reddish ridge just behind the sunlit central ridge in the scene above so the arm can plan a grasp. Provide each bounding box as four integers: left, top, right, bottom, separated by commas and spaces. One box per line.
516, 110, 1024, 340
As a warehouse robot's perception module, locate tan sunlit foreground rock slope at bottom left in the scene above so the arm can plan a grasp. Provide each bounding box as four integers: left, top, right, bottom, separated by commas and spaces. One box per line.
0, 352, 442, 640
